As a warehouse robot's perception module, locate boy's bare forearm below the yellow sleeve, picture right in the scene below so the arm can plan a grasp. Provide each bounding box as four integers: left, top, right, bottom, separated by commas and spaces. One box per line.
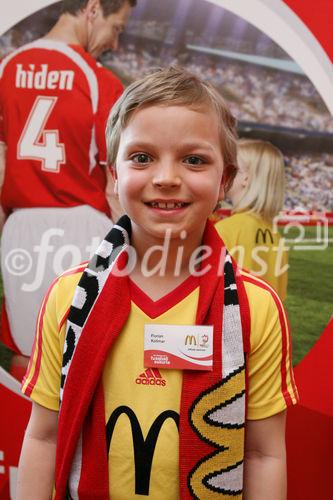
244, 411, 287, 500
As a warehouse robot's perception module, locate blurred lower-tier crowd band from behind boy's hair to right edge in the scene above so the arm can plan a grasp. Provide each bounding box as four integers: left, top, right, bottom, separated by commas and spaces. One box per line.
105, 43, 333, 132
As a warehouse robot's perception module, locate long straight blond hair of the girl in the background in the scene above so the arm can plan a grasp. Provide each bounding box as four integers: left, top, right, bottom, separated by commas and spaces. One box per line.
233, 139, 285, 222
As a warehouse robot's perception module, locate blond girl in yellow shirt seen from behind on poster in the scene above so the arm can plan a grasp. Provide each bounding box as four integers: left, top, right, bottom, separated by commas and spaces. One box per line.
216, 139, 288, 300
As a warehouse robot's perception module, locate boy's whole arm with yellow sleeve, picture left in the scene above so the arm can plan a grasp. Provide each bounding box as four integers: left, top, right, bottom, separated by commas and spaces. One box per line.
16, 273, 69, 500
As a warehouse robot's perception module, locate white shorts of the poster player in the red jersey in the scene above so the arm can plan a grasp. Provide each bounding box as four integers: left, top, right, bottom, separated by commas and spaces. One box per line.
1, 205, 112, 356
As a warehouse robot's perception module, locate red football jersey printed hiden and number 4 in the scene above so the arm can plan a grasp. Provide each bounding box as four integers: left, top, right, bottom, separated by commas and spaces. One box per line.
0, 39, 123, 214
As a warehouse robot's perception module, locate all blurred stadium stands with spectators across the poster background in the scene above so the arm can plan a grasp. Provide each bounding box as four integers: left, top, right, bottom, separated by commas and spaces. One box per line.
0, 0, 333, 211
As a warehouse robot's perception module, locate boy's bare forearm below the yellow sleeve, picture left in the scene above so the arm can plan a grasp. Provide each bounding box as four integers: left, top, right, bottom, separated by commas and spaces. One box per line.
16, 403, 58, 500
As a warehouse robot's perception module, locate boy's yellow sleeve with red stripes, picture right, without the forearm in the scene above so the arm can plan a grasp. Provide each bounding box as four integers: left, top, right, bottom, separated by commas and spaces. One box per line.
243, 274, 298, 420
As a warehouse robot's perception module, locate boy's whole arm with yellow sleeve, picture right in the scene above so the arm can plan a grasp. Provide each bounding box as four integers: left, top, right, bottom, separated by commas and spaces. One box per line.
243, 272, 298, 500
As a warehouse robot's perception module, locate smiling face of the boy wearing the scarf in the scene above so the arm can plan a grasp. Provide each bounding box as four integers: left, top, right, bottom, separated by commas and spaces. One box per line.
116, 106, 223, 244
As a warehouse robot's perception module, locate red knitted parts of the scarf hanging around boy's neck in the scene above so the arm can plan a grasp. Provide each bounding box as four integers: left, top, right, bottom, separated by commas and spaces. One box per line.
55, 223, 249, 500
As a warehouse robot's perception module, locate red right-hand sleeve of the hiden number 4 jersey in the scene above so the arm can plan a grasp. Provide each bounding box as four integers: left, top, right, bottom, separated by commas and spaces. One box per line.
95, 67, 123, 165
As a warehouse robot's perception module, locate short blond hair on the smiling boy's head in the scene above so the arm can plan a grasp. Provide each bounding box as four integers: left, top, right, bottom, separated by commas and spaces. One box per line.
106, 66, 237, 189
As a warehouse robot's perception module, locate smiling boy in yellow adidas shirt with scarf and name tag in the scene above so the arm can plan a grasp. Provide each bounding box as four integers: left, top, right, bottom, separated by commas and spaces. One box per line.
18, 68, 297, 500
